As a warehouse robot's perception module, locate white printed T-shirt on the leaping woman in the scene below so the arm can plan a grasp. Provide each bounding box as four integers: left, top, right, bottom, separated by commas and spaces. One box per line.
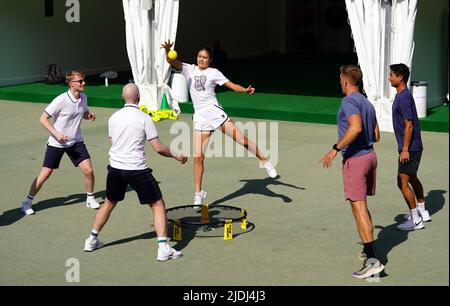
181, 63, 228, 110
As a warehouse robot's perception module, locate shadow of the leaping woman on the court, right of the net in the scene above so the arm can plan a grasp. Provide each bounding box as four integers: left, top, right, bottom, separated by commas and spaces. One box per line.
210, 176, 305, 206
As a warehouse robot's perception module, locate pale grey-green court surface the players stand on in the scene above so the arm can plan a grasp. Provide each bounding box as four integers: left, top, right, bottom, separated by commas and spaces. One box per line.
0, 100, 449, 286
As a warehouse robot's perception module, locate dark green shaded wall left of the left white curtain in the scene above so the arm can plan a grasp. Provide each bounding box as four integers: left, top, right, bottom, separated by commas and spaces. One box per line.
0, 0, 129, 86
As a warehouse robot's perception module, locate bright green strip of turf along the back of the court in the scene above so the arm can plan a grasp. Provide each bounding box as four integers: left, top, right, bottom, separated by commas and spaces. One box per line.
0, 83, 449, 132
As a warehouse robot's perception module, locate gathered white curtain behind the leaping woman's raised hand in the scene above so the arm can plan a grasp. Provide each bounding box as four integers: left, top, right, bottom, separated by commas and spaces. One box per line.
122, 0, 179, 111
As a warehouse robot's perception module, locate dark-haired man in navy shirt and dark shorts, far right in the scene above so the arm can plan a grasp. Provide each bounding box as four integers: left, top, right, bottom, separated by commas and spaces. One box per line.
389, 64, 431, 231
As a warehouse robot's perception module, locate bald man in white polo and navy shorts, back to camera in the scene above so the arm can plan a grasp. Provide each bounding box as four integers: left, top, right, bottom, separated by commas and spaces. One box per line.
84, 83, 187, 261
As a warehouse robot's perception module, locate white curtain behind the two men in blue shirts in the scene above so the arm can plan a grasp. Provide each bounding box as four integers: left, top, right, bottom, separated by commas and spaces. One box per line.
345, 0, 417, 131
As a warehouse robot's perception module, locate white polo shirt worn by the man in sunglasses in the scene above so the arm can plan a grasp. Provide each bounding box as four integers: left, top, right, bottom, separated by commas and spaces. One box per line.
45, 90, 89, 148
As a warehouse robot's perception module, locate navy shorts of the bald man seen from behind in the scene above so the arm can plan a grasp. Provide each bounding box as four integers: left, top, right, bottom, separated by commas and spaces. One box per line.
106, 166, 162, 204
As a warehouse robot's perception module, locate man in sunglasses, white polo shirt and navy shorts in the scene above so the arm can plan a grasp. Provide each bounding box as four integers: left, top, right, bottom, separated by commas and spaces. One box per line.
20, 71, 100, 215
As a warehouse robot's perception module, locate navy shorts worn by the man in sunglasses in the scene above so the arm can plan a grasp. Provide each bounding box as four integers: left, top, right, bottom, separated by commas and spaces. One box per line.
42, 141, 91, 169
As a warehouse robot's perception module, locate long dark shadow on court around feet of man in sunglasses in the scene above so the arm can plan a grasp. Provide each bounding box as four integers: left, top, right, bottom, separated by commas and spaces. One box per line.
0, 189, 110, 226
